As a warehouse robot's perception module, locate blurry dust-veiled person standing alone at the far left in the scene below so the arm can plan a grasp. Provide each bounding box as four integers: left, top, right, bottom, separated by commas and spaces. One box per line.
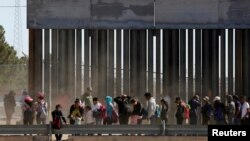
4, 91, 16, 125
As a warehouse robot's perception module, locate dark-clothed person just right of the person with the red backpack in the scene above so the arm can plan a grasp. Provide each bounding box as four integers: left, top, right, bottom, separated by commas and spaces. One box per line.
188, 94, 201, 125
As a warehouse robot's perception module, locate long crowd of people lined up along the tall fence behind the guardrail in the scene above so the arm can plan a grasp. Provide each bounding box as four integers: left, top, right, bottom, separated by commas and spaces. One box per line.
4, 87, 250, 125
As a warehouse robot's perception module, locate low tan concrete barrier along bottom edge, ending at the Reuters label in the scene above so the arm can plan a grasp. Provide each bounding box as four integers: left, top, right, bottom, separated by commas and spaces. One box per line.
68, 136, 208, 141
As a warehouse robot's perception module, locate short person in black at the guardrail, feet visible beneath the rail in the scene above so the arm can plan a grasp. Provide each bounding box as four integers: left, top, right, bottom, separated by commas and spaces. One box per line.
51, 104, 67, 141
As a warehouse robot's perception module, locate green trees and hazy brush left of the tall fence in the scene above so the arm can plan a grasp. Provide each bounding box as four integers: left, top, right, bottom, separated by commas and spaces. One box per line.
0, 25, 28, 92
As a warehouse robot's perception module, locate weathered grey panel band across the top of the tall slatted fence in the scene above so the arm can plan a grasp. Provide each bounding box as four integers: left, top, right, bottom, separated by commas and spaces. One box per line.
27, 0, 250, 29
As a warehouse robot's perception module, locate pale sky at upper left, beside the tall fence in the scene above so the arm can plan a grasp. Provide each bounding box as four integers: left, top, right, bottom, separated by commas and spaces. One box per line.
0, 0, 28, 57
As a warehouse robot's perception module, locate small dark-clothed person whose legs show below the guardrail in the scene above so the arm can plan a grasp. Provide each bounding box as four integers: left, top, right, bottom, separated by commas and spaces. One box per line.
51, 104, 67, 141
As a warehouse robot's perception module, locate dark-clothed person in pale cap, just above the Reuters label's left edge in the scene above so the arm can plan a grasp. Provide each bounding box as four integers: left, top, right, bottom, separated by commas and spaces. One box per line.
201, 96, 213, 125
